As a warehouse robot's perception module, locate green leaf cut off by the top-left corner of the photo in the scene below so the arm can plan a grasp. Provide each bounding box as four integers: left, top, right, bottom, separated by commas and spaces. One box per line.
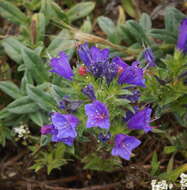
0, 1, 27, 24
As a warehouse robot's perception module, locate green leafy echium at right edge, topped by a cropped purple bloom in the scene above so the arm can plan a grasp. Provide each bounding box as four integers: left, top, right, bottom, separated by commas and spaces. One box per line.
141, 18, 187, 129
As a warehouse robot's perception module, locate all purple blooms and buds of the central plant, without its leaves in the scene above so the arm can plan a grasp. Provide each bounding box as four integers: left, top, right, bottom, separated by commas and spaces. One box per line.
41, 43, 155, 160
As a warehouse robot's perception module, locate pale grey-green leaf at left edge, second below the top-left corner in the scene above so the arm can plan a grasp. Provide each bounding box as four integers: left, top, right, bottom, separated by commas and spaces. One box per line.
2, 37, 25, 64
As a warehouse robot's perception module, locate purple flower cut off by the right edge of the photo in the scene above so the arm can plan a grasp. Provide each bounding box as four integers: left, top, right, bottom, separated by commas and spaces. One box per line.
177, 18, 187, 53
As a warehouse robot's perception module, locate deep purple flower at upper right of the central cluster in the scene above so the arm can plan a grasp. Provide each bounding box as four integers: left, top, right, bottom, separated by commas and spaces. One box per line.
118, 61, 145, 87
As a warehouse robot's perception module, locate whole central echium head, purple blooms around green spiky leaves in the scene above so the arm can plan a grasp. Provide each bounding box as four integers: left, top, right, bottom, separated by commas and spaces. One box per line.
41, 43, 155, 160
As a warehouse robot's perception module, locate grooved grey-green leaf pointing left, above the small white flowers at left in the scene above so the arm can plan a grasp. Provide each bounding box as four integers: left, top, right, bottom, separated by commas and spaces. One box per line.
6, 96, 39, 114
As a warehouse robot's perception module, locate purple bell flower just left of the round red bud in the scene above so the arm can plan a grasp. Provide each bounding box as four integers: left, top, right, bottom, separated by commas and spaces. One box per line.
50, 52, 74, 80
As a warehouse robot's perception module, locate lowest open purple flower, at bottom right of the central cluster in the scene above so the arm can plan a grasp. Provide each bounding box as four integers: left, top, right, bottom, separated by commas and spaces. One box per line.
112, 134, 141, 160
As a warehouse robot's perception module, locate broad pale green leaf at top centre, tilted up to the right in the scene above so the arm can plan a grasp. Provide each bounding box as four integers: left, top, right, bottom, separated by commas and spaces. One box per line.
66, 1, 95, 22
